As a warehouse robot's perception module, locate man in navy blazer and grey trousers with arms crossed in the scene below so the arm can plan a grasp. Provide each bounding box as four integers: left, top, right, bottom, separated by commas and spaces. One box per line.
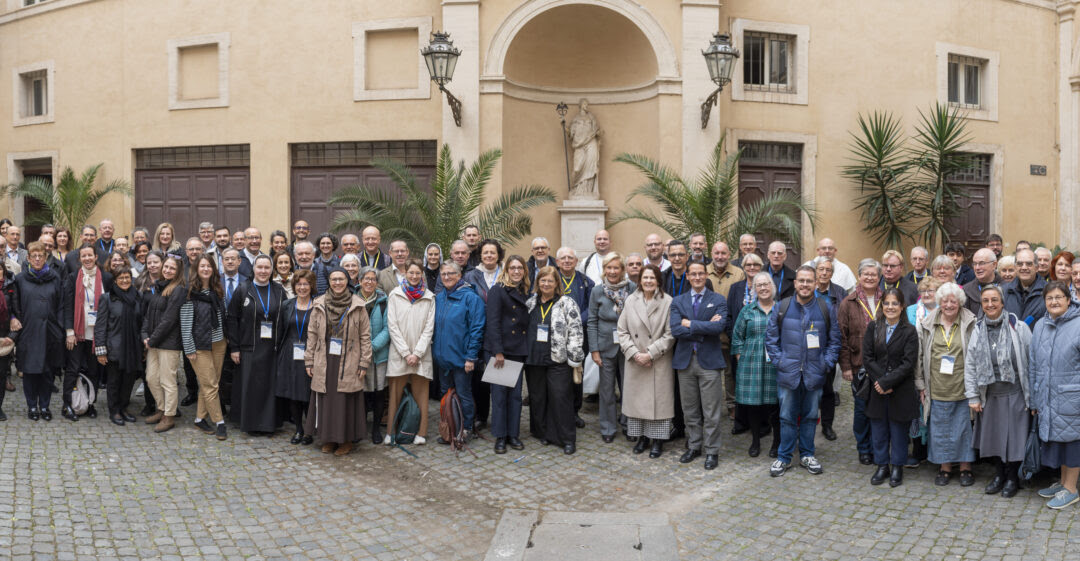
671, 262, 728, 469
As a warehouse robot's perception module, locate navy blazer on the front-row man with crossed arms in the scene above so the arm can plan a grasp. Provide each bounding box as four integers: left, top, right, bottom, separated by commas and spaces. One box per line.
671, 289, 728, 370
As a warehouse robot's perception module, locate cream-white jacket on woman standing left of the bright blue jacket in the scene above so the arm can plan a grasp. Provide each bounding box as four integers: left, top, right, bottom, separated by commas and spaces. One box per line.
387, 286, 435, 379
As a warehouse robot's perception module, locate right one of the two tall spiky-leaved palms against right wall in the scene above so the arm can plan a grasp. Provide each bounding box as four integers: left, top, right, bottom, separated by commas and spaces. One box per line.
912, 103, 974, 251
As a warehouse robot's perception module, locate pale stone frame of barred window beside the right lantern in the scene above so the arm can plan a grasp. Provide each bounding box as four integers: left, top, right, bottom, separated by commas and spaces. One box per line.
730, 17, 810, 105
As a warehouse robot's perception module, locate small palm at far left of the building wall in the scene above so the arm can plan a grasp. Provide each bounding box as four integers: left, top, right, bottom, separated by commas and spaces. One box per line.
0, 163, 132, 232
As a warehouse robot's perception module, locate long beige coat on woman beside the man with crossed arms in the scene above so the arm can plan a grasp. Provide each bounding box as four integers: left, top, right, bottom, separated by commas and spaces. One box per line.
619, 290, 675, 420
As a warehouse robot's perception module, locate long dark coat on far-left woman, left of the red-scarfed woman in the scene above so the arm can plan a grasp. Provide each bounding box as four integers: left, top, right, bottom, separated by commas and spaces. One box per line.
11, 268, 66, 374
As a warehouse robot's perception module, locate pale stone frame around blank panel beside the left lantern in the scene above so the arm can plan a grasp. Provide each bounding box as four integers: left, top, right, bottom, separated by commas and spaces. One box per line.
352, 16, 432, 102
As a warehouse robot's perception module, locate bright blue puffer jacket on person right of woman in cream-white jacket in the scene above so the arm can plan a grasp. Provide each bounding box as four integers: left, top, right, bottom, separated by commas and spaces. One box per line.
432, 281, 487, 370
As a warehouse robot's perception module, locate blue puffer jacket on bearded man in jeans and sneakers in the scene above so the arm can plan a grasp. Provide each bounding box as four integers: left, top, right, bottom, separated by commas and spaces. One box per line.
765, 296, 840, 390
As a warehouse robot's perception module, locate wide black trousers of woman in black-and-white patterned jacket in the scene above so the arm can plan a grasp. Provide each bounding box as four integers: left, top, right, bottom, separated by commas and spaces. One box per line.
525, 364, 577, 446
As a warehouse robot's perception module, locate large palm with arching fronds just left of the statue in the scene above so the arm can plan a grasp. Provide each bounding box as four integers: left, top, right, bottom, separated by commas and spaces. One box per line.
329, 145, 555, 255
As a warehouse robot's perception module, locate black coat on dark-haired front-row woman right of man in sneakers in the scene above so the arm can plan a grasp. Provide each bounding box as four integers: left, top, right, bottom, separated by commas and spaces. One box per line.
863, 318, 919, 423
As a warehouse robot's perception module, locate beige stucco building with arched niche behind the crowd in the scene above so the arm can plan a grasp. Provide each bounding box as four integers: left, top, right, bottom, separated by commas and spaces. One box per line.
0, 0, 1080, 262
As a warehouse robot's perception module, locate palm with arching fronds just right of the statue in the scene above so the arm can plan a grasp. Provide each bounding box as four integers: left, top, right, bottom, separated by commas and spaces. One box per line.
611, 136, 816, 248
